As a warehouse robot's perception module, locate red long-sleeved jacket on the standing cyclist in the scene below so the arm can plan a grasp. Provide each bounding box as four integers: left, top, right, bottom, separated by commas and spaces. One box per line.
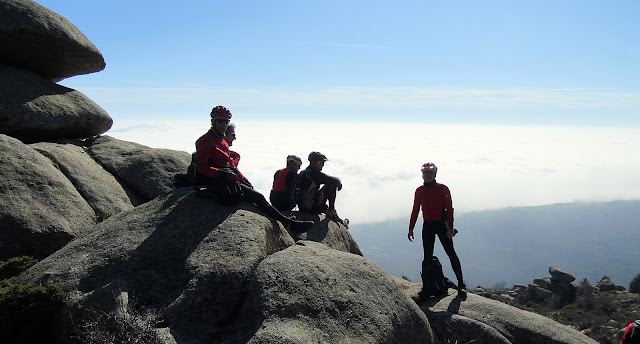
409, 182, 453, 229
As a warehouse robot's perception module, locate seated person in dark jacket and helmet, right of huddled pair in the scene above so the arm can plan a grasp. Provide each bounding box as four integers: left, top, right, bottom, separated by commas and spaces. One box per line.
295, 152, 346, 225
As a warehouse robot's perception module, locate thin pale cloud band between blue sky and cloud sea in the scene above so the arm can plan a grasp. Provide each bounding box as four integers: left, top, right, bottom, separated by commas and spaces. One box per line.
70, 85, 640, 123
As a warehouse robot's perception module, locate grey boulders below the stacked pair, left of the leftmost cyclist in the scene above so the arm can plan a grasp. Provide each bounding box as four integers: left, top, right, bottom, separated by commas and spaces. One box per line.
0, 134, 190, 260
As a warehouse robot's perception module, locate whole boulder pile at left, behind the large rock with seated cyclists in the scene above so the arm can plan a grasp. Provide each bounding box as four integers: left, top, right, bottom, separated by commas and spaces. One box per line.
0, 0, 190, 260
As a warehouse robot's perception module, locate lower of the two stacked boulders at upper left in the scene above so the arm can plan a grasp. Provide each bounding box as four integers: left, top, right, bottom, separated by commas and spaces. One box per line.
0, 63, 113, 143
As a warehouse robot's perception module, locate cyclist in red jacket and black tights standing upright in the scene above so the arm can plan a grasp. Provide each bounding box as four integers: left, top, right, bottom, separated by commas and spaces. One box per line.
407, 162, 466, 293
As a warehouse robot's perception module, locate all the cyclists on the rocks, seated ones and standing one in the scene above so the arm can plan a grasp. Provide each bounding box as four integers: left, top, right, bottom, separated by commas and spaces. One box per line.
195, 106, 466, 292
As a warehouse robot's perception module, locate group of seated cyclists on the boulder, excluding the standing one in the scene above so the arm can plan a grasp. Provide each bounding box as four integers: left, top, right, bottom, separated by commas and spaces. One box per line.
195, 106, 345, 233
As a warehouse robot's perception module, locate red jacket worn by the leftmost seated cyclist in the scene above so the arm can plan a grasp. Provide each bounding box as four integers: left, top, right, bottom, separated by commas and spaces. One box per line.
196, 129, 234, 178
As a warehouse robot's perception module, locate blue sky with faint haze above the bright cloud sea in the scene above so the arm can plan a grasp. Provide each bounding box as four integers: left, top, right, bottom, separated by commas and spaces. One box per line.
38, 0, 640, 127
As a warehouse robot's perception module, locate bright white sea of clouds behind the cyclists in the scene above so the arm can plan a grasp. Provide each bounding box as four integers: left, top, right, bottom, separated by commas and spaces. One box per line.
106, 118, 640, 223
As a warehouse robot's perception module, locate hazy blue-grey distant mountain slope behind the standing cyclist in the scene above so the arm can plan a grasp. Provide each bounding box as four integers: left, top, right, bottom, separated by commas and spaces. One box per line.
350, 201, 640, 288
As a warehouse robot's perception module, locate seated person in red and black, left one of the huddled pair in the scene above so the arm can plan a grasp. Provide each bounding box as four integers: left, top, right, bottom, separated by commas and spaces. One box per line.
269, 155, 302, 211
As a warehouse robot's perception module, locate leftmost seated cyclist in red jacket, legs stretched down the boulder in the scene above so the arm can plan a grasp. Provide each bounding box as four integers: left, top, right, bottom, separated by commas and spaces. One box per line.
196, 106, 314, 233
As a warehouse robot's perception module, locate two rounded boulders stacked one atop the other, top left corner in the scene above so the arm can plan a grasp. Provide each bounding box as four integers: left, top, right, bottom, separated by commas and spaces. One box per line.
0, 0, 113, 143
